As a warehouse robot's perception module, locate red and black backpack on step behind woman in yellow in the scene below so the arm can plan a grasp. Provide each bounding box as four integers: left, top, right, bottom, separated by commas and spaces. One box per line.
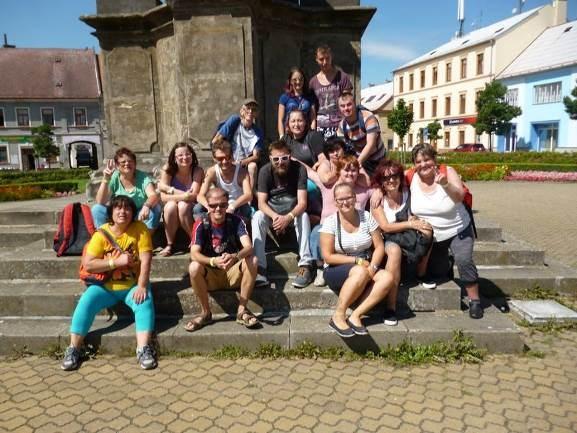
52, 203, 96, 257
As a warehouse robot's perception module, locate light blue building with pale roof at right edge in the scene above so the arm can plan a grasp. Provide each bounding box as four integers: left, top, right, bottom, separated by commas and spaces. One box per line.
497, 21, 577, 152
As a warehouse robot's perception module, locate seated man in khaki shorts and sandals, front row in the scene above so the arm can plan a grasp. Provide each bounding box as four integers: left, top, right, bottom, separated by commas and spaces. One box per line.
184, 187, 260, 332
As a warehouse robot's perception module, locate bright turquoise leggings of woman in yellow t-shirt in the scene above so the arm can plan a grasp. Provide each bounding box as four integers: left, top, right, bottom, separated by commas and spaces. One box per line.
70, 283, 154, 337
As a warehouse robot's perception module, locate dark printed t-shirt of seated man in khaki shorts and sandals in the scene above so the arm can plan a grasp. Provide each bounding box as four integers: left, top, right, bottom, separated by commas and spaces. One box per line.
192, 214, 248, 257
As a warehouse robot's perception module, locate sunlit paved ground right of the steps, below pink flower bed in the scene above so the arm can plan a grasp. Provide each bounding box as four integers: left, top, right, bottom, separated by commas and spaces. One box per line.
468, 182, 577, 268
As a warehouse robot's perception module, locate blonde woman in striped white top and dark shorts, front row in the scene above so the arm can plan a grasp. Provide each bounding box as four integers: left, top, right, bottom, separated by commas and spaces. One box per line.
320, 183, 395, 338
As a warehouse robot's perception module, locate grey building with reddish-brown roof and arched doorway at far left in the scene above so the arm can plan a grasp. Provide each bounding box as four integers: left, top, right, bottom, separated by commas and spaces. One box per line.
0, 46, 103, 170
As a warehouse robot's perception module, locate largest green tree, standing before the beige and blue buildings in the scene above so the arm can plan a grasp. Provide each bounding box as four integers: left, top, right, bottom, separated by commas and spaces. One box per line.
473, 80, 522, 151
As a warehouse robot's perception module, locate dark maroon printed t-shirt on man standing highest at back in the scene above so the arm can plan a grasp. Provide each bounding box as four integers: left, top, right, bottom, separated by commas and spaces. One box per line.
309, 69, 353, 128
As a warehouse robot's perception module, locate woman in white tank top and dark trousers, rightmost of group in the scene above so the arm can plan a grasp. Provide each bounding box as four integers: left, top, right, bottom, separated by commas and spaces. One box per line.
410, 144, 483, 319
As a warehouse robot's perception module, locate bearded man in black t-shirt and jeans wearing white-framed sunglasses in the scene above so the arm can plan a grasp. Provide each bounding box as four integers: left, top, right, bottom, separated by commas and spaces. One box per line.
252, 141, 313, 288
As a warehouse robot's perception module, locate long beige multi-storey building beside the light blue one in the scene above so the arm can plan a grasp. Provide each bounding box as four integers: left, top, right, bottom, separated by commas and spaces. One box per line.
393, 0, 567, 151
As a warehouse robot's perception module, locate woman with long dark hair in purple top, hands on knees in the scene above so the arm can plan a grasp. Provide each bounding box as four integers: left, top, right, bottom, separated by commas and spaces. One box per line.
158, 143, 204, 257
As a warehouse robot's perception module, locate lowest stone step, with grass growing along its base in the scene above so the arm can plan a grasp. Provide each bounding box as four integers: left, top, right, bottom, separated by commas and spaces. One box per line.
0, 308, 524, 355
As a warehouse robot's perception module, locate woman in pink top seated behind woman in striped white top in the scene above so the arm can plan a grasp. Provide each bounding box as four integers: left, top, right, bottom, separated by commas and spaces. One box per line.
307, 155, 372, 287
